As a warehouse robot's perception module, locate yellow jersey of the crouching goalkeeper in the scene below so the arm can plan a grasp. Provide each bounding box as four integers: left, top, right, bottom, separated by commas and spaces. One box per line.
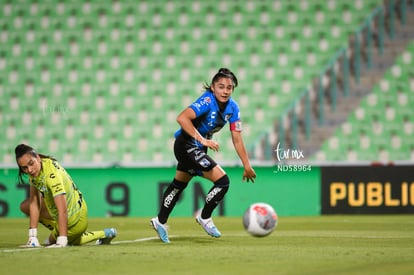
30, 158, 85, 226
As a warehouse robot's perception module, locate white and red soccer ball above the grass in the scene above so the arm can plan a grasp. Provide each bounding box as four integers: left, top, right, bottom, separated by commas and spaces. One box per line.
243, 202, 278, 237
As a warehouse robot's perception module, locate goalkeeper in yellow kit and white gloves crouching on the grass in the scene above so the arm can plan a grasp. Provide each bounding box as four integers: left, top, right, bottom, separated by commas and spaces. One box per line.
15, 144, 116, 247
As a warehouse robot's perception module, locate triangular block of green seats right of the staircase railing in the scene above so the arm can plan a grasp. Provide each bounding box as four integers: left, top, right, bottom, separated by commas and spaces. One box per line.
316, 40, 414, 162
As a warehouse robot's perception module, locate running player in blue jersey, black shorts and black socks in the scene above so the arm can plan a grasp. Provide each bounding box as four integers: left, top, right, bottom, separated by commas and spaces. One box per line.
151, 68, 256, 243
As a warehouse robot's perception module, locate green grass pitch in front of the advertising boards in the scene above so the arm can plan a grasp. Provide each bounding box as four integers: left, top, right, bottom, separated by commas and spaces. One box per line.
0, 215, 414, 275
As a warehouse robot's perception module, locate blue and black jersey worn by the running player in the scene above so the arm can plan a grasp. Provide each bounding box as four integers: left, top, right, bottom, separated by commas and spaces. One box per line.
175, 90, 241, 148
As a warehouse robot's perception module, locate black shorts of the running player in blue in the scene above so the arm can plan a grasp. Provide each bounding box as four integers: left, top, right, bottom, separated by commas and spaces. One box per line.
174, 134, 217, 176
